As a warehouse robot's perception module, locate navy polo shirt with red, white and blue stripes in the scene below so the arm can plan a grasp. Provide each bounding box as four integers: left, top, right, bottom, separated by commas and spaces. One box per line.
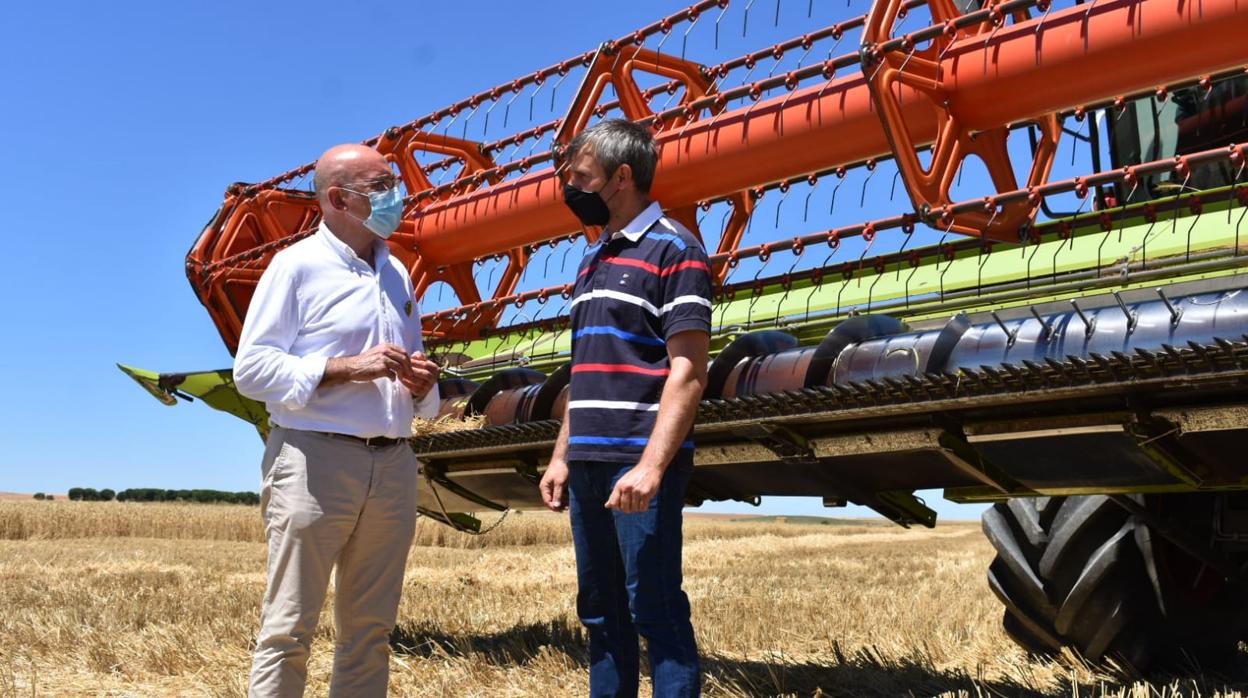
568, 204, 711, 462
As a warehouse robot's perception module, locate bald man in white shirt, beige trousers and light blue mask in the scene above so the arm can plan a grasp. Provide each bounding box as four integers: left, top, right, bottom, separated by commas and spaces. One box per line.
233, 145, 438, 697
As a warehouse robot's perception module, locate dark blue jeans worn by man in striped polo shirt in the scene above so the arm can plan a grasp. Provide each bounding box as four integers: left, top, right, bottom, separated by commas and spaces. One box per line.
568, 459, 701, 698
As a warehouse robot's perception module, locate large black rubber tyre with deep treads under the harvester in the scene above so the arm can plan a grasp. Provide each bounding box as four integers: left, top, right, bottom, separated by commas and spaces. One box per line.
983, 496, 1243, 673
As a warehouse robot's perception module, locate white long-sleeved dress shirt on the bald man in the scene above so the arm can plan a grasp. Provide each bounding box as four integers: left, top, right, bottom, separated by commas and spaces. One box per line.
233, 224, 438, 438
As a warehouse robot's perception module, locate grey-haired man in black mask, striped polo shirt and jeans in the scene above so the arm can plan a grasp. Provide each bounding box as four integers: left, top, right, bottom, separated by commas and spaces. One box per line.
540, 120, 711, 698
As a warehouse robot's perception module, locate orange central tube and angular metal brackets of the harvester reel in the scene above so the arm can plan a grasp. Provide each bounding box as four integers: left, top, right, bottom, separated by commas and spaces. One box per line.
187, 0, 1248, 351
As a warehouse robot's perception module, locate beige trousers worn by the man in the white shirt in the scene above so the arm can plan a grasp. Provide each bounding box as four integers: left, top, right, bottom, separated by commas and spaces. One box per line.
248, 427, 417, 698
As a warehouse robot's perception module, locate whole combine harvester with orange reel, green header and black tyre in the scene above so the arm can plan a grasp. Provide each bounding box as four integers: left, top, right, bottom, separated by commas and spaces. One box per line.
124, 0, 1248, 668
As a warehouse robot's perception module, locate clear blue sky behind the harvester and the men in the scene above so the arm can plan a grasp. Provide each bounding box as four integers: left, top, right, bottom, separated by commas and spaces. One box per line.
0, 0, 993, 518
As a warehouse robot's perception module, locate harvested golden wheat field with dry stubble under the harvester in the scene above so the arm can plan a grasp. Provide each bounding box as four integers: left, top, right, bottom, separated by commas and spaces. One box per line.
0, 502, 1248, 698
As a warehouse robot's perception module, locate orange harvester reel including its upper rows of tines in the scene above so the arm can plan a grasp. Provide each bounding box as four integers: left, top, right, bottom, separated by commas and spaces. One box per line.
187, 0, 1248, 348
